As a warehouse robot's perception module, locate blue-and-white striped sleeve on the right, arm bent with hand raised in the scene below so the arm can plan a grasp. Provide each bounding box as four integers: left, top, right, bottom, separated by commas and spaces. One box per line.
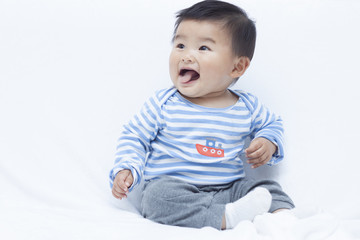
239, 91, 284, 166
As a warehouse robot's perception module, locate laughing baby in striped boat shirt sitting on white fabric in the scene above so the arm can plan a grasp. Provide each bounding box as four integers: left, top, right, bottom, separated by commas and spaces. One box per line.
110, 0, 294, 229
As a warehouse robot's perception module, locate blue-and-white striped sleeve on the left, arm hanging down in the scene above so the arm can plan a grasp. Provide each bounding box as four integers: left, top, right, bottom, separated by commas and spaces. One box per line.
109, 95, 161, 190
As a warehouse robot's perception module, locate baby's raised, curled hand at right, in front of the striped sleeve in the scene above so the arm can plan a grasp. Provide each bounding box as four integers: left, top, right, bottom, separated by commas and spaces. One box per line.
245, 137, 277, 168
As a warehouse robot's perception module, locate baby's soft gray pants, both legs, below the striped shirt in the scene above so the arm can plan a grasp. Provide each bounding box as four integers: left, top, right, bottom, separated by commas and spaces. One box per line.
141, 177, 294, 229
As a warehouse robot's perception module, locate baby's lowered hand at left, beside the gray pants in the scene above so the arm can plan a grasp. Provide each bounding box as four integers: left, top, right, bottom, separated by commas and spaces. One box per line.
112, 169, 134, 200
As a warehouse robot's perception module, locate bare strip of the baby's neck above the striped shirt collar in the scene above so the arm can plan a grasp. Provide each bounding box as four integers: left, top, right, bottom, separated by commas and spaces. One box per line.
182, 90, 239, 108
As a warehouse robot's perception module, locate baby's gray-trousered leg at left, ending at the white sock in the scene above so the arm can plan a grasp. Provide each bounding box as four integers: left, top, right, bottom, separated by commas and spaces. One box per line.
141, 177, 225, 229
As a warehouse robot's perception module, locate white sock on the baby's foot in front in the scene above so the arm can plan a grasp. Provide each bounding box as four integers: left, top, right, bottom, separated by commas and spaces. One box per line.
225, 187, 272, 229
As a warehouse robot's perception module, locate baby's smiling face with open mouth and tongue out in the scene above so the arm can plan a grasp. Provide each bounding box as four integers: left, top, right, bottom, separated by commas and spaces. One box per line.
169, 20, 238, 98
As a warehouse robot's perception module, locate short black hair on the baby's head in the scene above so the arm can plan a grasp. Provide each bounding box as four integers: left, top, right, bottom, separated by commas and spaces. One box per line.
174, 0, 256, 60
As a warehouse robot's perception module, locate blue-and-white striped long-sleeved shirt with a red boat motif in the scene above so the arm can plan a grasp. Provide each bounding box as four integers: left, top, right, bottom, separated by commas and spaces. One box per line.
110, 88, 284, 189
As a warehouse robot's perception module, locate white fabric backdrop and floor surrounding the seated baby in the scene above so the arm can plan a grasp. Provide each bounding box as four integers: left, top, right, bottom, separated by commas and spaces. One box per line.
0, 0, 360, 240
